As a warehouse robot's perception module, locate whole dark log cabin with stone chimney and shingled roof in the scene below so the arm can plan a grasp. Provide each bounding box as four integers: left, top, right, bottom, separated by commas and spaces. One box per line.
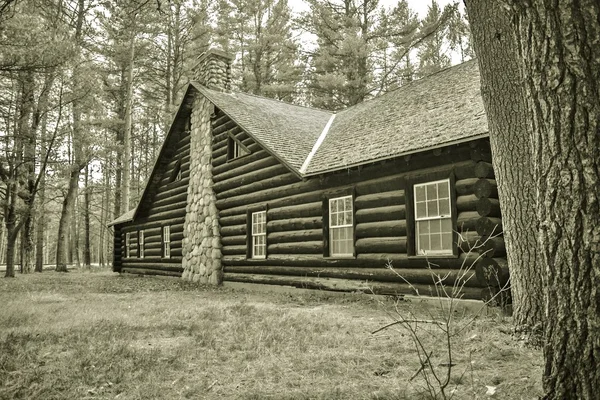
111, 50, 508, 299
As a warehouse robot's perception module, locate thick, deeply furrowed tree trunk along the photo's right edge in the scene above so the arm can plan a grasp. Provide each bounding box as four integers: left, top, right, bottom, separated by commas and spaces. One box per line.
504, 0, 600, 399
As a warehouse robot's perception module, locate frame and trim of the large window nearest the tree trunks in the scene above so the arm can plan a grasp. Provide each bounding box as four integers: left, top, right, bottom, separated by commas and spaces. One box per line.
406, 174, 458, 258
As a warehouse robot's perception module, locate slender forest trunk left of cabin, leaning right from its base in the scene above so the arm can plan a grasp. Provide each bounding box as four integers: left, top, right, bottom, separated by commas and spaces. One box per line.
56, 0, 87, 272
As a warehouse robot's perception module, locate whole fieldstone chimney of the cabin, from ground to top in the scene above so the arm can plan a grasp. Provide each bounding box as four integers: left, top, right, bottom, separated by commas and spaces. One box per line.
182, 50, 232, 285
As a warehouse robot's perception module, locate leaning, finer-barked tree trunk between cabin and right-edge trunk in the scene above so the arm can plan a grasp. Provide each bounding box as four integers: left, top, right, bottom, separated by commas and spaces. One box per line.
465, 0, 544, 331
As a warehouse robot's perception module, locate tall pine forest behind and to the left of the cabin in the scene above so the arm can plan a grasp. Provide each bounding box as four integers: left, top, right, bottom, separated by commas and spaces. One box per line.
0, 0, 473, 274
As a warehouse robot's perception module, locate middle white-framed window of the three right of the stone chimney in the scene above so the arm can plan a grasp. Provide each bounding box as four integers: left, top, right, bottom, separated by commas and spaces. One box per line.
329, 196, 354, 257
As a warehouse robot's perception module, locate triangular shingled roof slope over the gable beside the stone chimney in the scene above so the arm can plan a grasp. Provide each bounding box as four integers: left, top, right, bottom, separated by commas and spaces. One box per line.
194, 83, 331, 172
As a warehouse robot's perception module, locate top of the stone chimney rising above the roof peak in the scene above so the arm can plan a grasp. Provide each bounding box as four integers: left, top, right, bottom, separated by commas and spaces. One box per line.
193, 49, 233, 91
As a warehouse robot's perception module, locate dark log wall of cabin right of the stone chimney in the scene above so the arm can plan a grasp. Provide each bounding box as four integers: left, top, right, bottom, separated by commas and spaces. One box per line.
213, 108, 500, 298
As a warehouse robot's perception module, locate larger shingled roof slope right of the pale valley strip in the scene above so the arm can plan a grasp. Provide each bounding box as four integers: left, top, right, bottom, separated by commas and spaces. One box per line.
306, 60, 488, 175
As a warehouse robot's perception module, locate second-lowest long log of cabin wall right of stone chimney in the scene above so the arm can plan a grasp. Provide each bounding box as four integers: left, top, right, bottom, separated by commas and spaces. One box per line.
225, 265, 481, 287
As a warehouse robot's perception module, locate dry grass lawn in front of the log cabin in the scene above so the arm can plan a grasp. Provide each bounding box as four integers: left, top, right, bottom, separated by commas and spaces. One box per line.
0, 271, 542, 399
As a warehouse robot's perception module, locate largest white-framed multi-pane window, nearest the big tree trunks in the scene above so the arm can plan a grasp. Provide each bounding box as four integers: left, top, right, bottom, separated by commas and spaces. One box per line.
414, 179, 453, 255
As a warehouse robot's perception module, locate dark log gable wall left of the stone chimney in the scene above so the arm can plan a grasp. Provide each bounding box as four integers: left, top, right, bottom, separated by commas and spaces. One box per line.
115, 126, 190, 276
